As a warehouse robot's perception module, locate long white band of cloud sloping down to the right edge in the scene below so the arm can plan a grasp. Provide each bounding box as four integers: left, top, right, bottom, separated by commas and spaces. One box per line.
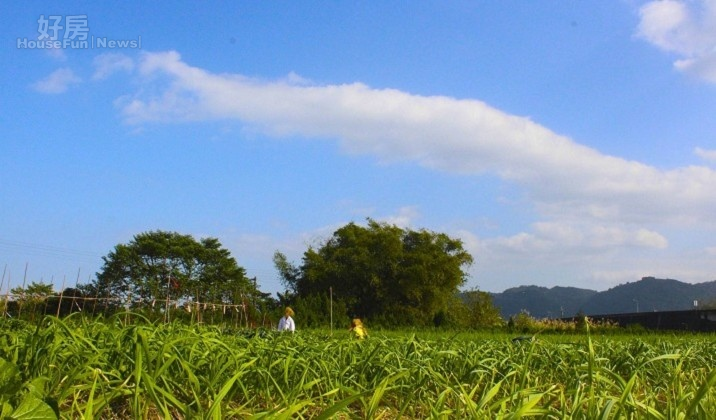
119, 52, 716, 231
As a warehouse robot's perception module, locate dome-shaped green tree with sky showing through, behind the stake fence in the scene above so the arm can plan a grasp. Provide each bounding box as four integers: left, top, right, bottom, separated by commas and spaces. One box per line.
91, 231, 261, 304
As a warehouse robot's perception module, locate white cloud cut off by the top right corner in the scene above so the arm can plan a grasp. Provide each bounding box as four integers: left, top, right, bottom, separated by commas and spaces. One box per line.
637, 0, 716, 83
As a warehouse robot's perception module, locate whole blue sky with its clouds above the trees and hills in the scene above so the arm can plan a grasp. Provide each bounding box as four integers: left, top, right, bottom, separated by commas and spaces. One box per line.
0, 0, 716, 292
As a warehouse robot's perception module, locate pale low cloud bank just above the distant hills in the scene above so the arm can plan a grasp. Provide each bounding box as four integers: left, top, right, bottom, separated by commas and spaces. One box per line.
457, 224, 716, 292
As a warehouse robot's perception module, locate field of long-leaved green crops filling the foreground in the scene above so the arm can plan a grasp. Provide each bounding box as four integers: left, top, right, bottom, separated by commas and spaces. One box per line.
0, 314, 716, 419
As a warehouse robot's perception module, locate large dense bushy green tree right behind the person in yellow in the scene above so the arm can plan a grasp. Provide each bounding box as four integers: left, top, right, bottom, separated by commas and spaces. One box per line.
274, 219, 473, 325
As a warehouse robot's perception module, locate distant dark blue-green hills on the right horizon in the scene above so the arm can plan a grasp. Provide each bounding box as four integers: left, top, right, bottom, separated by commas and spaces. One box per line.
492, 277, 716, 319
